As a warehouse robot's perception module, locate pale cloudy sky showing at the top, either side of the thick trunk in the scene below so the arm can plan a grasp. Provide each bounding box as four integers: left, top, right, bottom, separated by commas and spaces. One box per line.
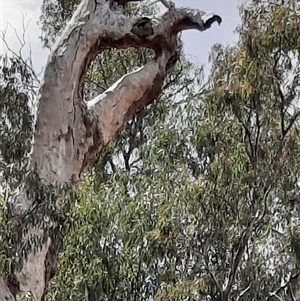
0, 0, 241, 72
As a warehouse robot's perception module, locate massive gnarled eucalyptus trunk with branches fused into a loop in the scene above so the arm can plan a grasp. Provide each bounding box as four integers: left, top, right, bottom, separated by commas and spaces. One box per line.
0, 0, 221, 300
